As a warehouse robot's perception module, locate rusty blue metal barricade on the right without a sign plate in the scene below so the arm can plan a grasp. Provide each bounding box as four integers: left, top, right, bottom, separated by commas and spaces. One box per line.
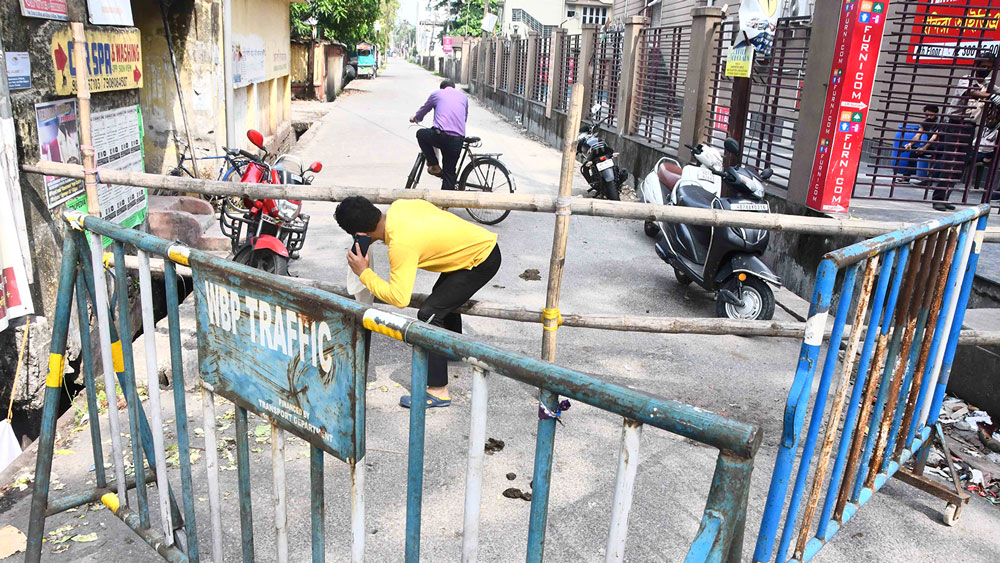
754, 205, 989, 563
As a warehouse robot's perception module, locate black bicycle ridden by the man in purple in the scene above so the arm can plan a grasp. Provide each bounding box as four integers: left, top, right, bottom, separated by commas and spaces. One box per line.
405, 131, 515, 225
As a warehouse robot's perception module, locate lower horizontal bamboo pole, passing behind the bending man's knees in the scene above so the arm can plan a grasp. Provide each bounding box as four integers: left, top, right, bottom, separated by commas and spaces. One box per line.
117, 256, 1000, 346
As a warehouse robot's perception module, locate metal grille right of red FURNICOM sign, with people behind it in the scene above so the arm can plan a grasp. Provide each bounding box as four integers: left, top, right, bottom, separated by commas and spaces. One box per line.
853, 0, 1000, 205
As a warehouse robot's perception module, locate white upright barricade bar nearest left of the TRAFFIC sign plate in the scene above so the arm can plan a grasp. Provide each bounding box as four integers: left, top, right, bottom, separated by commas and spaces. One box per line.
138, 250, 173, 545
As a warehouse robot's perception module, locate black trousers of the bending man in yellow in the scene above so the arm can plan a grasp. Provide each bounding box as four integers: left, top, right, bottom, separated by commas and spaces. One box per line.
417, 244, 500, 387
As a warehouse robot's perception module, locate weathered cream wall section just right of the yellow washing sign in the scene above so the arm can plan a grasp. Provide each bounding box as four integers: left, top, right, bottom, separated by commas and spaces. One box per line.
132, 0, 226, 179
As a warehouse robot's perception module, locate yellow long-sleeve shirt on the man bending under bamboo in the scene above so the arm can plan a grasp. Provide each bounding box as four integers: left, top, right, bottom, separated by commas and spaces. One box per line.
361, 199, 497, 307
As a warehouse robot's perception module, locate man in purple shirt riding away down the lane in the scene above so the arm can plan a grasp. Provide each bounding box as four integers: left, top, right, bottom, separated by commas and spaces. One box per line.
410, 79, 469, 190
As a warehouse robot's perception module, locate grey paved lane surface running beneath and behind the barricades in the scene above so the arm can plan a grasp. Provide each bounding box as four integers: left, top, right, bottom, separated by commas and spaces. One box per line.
0, 60, 1000, 563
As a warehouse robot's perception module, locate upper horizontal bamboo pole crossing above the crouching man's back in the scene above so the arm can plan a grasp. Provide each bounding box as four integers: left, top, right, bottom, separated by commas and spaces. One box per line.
21, 161, 1000, 242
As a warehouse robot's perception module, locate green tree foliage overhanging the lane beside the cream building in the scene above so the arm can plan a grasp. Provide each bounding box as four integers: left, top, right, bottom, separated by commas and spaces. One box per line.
291, 0, 399, 48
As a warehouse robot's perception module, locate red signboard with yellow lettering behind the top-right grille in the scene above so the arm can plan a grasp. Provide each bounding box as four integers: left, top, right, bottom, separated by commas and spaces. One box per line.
907, 0, 1000, 65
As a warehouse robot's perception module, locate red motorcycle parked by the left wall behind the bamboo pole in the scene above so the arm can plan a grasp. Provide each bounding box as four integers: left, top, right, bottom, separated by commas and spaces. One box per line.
219, 129, 323, 276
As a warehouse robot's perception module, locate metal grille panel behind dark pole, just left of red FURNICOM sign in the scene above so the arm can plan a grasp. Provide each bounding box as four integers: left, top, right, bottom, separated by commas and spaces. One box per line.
705, 17, 812, 188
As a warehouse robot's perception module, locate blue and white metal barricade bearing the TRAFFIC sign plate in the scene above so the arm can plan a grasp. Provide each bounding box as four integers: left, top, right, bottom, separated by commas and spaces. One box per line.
26, 213, 760, 563
